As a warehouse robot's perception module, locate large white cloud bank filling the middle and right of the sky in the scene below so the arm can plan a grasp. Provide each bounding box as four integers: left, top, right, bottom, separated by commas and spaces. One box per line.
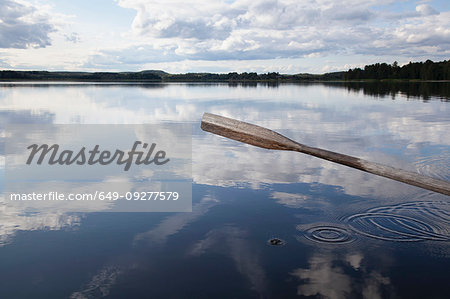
85, 0, 450, 64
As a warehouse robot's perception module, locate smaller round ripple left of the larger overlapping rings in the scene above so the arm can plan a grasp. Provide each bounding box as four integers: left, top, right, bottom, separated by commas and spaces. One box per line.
297, 225, 355, 244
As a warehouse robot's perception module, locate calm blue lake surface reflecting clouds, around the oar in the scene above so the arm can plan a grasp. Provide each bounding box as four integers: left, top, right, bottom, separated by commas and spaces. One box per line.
0, 82, 450, 298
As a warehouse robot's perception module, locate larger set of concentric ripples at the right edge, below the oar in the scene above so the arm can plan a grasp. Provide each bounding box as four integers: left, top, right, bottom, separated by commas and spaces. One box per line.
345, 201, 450, 242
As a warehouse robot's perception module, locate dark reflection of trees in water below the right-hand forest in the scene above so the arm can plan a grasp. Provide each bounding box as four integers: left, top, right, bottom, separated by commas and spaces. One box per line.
325, 81, 450, 101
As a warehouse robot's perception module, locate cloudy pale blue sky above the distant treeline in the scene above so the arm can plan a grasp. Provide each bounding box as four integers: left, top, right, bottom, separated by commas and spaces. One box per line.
0, 0, 450, 74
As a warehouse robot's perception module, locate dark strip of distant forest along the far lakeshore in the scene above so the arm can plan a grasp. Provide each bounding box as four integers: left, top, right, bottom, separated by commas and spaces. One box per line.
0, 60, 450, 82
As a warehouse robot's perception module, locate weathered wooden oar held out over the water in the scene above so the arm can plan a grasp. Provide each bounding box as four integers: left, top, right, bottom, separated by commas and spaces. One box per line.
201, 113, 450, 195
